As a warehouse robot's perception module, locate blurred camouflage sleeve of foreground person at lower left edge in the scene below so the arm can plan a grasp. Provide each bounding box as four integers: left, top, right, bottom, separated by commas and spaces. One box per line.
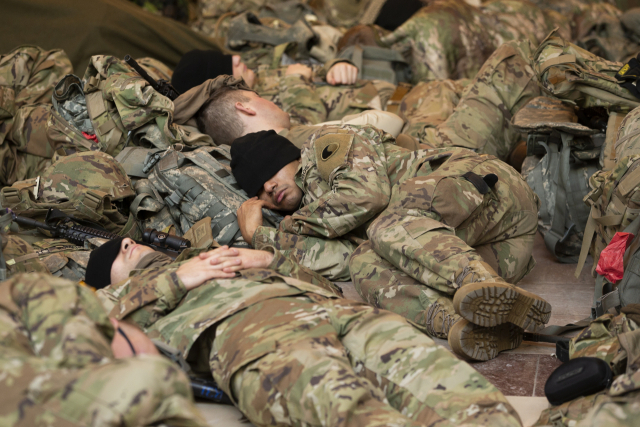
0, 273, 113, 368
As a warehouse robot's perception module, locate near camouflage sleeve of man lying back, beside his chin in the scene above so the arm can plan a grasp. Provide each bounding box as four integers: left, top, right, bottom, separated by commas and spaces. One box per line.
96, 270, 187, 328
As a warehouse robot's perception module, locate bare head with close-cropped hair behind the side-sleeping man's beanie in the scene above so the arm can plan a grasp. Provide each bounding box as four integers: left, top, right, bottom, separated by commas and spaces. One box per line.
196, 87, 291, 145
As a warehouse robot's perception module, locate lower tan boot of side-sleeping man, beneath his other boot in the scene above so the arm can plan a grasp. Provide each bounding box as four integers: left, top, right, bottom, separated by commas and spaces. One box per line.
448, 319, 524, 361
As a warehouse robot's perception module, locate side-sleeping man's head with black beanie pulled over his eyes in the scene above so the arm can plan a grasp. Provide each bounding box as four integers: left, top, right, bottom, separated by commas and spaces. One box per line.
231, 130, 304, 212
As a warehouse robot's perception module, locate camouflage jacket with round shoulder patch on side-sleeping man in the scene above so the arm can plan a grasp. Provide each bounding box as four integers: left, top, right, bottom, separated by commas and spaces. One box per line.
253, 125, 477, 249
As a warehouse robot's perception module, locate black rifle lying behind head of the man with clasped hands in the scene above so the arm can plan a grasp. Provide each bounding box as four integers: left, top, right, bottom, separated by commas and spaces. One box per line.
7, 208, 191, 259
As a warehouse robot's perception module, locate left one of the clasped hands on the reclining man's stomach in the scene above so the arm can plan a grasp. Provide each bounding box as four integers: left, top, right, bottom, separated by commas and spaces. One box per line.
176, 246, 242, 290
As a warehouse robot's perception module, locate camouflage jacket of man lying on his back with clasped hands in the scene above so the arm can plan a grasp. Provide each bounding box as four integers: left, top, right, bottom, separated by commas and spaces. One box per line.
97, 250, 341, 358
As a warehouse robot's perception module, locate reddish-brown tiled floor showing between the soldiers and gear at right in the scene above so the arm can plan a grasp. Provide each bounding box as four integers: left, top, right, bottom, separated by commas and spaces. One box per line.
199, 236, 594, 427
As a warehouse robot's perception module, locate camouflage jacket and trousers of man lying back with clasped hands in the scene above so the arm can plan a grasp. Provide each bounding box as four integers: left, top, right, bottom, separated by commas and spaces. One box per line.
98, 247, 519, 426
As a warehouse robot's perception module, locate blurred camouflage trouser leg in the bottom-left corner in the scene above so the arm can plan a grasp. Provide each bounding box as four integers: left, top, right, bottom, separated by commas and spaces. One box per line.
0, 356, 207, 427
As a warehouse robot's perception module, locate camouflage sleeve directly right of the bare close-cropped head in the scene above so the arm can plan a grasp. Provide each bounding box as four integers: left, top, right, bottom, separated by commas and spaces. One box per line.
279, 74, 327, 125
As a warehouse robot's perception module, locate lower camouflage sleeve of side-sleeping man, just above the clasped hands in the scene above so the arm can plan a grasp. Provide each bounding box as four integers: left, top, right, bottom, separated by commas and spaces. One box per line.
252, 227, 357, 282
